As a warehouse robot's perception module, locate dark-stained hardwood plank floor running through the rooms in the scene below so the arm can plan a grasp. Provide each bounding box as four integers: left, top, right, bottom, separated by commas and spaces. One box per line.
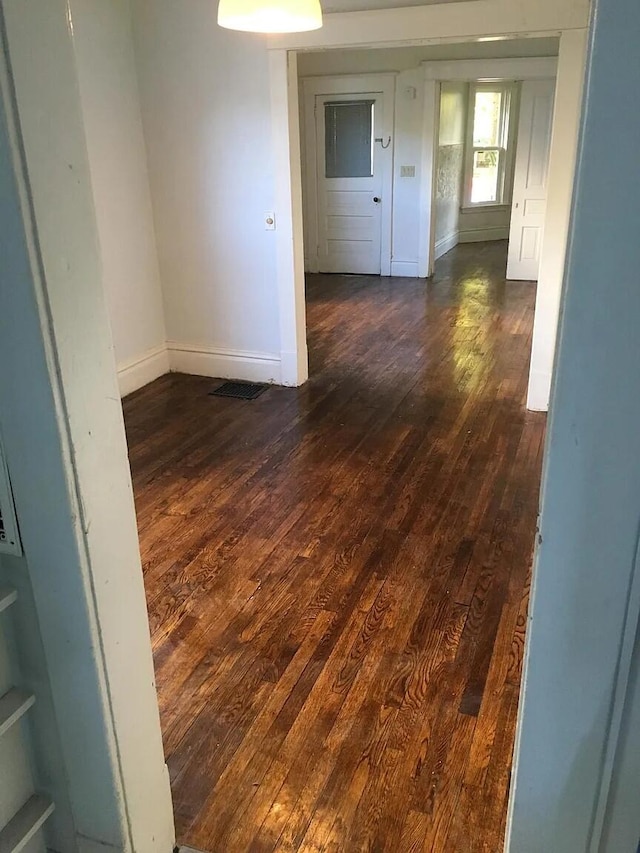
124, 243, 545, 853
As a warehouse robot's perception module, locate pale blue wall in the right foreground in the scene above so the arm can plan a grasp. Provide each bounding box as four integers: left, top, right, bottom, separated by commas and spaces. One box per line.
510, 0, 640, 853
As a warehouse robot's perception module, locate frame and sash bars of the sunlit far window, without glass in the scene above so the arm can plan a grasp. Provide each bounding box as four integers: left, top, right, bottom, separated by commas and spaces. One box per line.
462, 81, 518, 211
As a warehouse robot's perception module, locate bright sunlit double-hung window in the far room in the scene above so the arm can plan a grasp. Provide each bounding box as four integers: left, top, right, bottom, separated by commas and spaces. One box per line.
464, 83, 513, 207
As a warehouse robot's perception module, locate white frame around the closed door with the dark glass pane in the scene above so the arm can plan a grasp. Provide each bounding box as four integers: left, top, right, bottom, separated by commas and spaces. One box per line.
301, 74, 396, 275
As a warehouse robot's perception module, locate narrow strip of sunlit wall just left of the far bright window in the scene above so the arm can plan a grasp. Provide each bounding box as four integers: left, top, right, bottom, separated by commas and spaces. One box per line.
435, 83, 469, 259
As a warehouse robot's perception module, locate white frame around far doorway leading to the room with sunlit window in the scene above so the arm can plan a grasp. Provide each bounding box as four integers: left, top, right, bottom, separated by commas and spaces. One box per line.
418, 56, 558, 277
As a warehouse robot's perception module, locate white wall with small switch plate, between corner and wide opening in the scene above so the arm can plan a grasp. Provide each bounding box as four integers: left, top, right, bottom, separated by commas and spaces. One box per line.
132, 0, 280, 381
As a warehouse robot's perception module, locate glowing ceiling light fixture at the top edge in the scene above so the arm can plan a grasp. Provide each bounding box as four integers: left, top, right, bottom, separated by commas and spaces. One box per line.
218, 0, 322, 33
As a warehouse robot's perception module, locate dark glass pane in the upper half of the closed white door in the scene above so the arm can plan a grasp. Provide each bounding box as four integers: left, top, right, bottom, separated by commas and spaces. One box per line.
324, 101, 373, 178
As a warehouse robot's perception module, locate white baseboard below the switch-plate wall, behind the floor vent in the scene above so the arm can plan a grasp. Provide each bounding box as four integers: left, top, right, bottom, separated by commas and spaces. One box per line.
167, 341, 282, 384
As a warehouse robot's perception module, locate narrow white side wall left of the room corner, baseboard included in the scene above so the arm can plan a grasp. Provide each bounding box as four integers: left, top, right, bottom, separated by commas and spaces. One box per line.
71, 0, 169, 394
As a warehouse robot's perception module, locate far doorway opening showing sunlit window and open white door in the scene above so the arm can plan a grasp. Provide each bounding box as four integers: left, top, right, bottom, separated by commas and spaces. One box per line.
431, 72, 556, 281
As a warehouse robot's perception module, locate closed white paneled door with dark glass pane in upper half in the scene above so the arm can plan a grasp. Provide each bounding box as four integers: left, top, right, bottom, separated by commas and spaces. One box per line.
315, 93, 390, 275
